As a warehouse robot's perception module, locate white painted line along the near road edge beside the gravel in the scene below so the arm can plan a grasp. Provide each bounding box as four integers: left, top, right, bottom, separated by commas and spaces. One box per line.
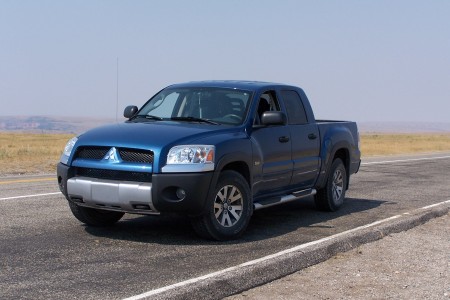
123, 200, 450, 300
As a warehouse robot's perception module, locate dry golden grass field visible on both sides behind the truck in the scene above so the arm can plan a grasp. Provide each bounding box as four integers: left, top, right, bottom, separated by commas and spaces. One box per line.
0, 132, 450, 176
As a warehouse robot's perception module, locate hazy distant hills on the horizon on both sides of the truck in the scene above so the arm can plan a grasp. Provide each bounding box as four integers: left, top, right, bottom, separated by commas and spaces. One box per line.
0, 116, 450, 134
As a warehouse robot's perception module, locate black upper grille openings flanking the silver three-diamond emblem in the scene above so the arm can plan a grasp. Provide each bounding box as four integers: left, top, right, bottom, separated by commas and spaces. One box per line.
74, 146, 153, 164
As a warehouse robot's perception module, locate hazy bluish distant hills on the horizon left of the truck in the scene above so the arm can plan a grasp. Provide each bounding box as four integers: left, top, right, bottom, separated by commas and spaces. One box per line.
0, 116, 118, 134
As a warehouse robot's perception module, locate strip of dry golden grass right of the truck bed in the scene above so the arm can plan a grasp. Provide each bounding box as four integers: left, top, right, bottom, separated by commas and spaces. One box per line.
361, 133, 450, 156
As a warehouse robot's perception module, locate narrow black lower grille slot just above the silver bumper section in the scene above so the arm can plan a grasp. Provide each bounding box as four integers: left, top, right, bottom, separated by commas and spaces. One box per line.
75, 168, 152, 182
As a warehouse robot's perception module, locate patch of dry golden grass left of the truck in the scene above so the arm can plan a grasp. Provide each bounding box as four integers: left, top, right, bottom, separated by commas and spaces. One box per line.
0, 132, 73, 175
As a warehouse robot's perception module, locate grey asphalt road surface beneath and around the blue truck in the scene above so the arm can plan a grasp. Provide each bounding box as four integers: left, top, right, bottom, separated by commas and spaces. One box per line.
0, 153, 450, 299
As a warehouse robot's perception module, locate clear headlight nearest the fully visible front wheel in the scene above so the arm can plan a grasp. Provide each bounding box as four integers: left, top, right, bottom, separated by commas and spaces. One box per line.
162, 145, 215, 172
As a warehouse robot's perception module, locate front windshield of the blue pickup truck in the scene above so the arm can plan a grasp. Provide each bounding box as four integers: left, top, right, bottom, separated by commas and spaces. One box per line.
138, 88, 250, 125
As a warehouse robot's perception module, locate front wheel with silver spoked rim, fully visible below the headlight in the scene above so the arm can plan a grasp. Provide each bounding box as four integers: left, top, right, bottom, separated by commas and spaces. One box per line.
192, 171, 253, 241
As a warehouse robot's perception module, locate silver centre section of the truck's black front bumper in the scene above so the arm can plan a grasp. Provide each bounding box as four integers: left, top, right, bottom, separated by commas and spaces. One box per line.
67, 177, 159, 215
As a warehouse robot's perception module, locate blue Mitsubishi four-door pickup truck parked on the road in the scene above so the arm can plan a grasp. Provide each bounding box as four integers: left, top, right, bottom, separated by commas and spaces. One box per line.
57, 81, 360, 240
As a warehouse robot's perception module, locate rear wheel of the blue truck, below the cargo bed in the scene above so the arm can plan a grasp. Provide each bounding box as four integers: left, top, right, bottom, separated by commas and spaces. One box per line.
314, 158, 347, 211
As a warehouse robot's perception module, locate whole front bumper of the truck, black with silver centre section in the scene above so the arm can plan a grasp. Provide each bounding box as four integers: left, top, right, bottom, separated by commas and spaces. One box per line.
57, 163, 213, 215
